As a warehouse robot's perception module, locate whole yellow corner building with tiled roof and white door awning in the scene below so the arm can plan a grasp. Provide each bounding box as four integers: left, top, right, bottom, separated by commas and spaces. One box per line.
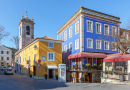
15, 36, 62, 79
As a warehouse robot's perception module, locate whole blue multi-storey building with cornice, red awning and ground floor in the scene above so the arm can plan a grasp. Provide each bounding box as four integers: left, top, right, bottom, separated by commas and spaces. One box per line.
57, 7, 120, 82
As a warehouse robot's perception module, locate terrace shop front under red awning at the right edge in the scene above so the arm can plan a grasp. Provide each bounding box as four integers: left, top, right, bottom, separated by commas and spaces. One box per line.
101, 53, 130, 83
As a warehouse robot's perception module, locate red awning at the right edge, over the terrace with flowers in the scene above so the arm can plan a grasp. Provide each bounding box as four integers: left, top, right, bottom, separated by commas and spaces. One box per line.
103, 53, 130, 62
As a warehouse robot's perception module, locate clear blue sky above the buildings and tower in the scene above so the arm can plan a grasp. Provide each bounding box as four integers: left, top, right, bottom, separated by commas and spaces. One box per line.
0, 0, 130, 48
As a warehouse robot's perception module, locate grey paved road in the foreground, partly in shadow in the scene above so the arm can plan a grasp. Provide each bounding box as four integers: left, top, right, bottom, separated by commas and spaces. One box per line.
0, 71, 130, 90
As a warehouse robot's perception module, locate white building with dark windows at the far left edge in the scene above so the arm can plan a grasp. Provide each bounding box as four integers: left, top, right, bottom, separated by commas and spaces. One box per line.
0, 45, 12, 66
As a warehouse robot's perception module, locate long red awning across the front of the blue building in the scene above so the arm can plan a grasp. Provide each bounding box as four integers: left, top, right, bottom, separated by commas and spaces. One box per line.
68, 52, 107, 59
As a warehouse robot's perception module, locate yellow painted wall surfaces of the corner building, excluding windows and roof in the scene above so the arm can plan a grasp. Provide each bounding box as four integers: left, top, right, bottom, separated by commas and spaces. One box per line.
21, 41, 62, 77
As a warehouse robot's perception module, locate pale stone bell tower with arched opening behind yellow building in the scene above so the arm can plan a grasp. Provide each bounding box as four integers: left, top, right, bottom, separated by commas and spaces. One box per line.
18, 13, 35, 50
